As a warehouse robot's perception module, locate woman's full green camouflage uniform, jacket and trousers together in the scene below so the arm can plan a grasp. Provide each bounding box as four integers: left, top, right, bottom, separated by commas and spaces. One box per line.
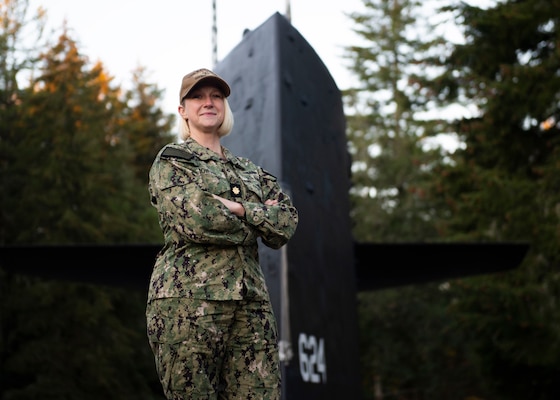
146, 138, 298, 400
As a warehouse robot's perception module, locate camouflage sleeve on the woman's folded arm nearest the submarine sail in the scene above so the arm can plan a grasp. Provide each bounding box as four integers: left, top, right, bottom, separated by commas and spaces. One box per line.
243, 169, 299, 249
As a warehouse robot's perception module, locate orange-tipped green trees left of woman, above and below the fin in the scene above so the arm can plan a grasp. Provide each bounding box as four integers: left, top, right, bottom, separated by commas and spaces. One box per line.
0, 0, 174, 400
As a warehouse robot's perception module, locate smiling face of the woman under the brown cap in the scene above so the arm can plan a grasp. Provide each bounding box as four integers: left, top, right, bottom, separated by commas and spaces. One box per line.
179, 85, 225, 133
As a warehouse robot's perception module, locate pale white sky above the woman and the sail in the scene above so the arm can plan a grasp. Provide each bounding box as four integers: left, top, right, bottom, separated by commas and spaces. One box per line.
29, 0, 364, 113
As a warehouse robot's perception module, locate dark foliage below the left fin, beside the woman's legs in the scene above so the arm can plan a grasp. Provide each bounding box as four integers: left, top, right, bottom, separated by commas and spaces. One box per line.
0, 275, 163, 400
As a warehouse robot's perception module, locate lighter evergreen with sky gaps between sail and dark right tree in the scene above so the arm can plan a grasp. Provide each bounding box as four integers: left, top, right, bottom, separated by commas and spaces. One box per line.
345, 0, 447, 242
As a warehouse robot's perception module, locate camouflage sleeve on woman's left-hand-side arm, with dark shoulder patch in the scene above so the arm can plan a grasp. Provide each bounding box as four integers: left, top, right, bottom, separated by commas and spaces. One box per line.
149, 157, 257, 245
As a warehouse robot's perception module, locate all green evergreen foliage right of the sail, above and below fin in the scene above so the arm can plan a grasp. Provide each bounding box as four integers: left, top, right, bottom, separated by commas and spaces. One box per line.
349, 0, 560, 400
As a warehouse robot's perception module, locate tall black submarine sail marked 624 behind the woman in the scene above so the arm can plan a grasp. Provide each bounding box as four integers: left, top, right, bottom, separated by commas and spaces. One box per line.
215, 13, 360, 400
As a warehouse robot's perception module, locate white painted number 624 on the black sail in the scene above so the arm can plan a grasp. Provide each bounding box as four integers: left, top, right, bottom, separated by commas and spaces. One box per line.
298, 333, 327, 383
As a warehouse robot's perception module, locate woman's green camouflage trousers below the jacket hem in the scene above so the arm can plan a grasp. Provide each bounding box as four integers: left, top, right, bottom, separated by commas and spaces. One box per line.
147, 299, 281, 400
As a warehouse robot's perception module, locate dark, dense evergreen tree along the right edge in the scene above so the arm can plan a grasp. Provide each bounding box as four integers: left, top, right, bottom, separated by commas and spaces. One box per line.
426, 0, 560, 400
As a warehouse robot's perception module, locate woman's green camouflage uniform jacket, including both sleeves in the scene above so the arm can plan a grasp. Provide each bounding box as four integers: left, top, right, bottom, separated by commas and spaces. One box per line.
148, 138, 298, 301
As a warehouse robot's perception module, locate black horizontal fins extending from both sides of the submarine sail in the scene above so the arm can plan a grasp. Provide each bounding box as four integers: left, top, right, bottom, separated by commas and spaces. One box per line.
0, 243, 529, 291
